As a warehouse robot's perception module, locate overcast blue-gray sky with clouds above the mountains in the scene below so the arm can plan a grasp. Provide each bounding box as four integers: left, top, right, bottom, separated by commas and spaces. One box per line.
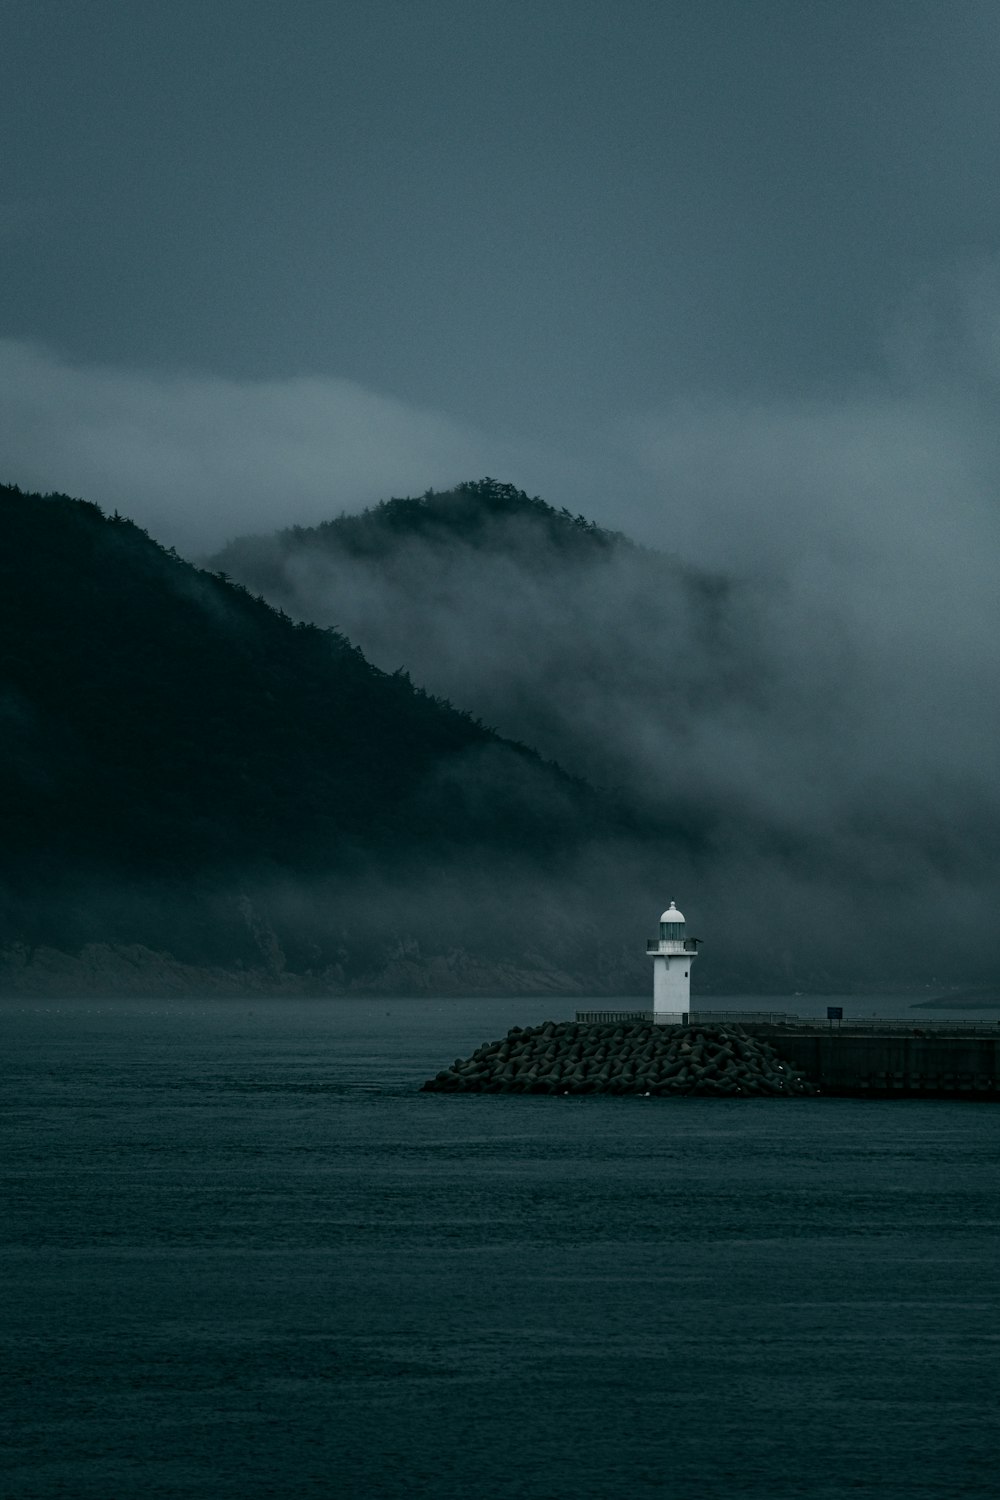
0, 0, 1000, 561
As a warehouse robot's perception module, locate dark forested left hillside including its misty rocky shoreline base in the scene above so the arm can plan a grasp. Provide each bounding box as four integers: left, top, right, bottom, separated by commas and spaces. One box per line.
0, 488, 665, 989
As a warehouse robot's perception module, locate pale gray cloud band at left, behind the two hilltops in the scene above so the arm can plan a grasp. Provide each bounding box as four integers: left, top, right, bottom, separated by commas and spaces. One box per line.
0, 339, 578, 551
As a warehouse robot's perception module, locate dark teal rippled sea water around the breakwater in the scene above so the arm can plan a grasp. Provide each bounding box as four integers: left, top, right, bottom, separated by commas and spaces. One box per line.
0, 999, 1000, 1500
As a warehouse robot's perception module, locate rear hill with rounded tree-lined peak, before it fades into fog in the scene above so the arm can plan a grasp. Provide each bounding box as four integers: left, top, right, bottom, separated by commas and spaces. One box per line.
207, 479, 743, 822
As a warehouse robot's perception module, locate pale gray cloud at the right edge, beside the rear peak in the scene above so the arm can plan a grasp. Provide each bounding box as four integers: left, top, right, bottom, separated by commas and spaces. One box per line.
630, 275, 1000, 806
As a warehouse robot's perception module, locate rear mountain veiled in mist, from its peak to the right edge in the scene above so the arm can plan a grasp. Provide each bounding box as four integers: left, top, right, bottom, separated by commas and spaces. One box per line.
210, 480, 1000, 987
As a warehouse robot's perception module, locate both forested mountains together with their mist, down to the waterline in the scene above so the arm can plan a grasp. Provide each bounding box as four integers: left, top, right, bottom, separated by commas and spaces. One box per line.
7, 480, 1000, 995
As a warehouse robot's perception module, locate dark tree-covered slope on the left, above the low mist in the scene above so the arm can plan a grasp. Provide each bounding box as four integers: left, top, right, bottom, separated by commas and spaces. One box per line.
0, 488, 601, 894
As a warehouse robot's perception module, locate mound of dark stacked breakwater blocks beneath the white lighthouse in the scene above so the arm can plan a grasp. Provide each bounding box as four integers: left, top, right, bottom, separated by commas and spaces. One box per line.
423, 1022, 816, 1097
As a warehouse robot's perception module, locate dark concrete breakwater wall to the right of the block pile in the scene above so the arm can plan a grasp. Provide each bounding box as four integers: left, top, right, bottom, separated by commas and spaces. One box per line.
773, 1026, 1000, 1100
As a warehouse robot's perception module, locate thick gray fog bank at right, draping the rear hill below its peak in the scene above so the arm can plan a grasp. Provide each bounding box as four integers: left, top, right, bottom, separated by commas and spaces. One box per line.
199, 279, 1000, 972
